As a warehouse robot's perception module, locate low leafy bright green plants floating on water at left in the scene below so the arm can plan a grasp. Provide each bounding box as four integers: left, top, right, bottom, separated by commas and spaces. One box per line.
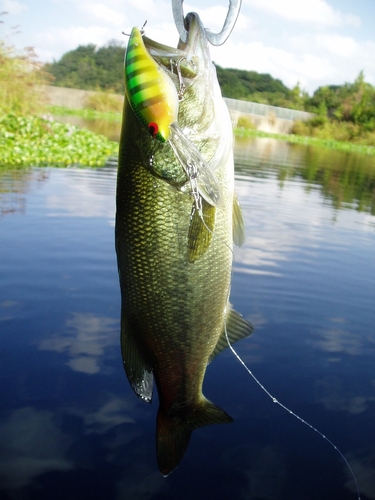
0, 113, 118, 167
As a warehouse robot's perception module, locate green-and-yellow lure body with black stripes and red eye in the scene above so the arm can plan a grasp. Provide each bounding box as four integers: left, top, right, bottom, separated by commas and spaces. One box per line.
125, 28, 179, 142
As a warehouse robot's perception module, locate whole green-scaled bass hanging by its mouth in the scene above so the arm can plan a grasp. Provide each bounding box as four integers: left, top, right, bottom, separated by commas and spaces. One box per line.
115, 13, 253, 476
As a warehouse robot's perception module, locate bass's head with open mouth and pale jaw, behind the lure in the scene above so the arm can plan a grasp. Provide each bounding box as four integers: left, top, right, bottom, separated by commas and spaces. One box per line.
129, 12, 232, 189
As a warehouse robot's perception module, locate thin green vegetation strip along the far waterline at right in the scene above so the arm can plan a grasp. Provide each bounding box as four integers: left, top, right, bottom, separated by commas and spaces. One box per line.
234, 128, 375, 155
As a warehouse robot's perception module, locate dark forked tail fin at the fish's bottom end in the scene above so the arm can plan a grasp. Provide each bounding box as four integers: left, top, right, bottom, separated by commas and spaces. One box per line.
156, 397, 233, 476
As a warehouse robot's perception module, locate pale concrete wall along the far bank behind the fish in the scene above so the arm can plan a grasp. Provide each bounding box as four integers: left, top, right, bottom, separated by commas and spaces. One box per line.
42, 85, 314, 134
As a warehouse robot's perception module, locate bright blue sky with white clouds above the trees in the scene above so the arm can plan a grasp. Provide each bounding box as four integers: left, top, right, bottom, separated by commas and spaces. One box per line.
0, 0, 375, 95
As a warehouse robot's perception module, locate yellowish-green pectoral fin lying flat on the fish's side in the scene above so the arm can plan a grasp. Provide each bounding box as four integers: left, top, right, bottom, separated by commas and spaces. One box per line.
188, 199, 216, 262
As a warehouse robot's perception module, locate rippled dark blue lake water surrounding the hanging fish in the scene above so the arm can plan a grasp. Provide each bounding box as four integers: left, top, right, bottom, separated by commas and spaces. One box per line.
0, 139, 375, 500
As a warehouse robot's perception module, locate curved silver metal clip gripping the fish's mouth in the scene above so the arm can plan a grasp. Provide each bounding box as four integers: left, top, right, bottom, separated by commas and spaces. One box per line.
172, 0, 242, 45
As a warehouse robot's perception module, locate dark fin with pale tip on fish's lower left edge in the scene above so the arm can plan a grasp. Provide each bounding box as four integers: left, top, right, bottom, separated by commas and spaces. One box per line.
121, 312, 154, 403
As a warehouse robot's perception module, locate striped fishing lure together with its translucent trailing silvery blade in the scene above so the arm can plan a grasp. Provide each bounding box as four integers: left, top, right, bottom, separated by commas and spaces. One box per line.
125, 27, 222, 209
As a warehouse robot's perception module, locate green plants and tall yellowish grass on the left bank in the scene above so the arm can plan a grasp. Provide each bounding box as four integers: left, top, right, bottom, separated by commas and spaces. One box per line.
0, 20, 118, 168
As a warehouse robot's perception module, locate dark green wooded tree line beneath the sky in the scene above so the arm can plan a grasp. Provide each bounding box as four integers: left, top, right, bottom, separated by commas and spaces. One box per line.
43, 41, 375, 137
